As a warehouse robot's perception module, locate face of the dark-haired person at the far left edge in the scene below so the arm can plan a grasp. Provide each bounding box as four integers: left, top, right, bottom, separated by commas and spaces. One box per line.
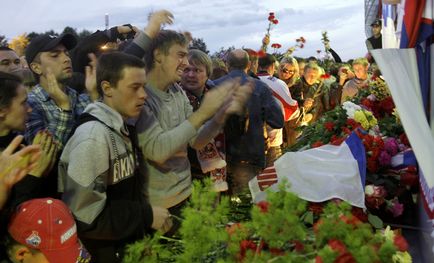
0, 84, 32, 131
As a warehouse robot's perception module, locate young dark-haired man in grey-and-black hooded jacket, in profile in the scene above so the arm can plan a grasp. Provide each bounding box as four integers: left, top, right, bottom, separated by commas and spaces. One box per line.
59, 52, 171, 262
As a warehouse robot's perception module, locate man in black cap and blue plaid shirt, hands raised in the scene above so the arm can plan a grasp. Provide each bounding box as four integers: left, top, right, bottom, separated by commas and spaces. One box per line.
25, 34, 95, 149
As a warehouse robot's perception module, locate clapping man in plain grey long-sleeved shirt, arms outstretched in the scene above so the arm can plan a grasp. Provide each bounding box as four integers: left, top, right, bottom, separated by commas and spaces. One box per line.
136, 30, 250, 225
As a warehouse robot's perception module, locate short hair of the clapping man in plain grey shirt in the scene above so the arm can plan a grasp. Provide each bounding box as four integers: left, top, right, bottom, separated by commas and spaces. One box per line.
144, 30, 188, 71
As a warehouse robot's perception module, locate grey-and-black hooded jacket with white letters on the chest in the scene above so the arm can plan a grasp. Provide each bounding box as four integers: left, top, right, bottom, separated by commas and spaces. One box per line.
59, 102, 153, 261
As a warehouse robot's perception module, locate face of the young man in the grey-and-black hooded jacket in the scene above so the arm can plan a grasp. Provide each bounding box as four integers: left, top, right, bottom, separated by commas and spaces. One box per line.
111, 67, 148, 118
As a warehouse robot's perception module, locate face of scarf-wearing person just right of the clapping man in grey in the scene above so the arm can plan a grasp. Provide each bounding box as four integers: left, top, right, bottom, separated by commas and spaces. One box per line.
181, 63, 208, 93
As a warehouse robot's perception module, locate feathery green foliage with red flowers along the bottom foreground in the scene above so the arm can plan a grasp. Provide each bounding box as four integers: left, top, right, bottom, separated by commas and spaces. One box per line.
124, 180, 406, 263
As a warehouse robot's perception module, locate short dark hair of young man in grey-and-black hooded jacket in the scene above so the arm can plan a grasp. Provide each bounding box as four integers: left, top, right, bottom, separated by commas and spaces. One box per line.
96, 52, 145, 97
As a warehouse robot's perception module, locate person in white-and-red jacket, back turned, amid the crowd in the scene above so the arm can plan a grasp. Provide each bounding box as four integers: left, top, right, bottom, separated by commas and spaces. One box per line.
258, 53, 300, 166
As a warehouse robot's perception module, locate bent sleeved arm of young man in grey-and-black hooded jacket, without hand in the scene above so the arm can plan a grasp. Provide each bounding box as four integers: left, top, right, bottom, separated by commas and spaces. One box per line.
59, 139, 152, 240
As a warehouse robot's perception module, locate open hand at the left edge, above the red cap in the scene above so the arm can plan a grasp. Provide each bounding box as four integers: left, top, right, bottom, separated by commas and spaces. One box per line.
0, 135, 41, 208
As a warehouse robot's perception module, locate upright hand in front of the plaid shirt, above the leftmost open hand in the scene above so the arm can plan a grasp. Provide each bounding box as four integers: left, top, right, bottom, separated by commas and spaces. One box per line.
29, 131, 58, 177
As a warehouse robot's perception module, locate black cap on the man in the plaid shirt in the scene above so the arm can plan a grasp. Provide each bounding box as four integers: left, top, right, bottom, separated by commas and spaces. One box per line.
26, 34, 77, 65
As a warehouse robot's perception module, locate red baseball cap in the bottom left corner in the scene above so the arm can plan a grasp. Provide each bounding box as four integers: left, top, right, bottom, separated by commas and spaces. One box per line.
8, 198, 91, 263
